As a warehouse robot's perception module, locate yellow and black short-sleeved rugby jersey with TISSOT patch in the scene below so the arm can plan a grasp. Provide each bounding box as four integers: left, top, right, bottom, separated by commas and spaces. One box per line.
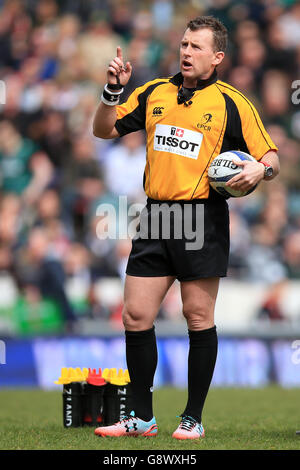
115, 72, 277, 200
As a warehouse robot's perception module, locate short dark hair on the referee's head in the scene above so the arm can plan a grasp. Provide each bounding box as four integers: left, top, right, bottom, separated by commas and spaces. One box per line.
187, 16, 228, 52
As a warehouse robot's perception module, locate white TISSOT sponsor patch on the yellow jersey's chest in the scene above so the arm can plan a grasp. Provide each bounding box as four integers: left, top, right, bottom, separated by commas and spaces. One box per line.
153, 124, 203, 160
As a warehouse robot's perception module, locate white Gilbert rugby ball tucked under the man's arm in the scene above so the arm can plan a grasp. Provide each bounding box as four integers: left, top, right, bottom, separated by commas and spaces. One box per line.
208, 150, 257, 198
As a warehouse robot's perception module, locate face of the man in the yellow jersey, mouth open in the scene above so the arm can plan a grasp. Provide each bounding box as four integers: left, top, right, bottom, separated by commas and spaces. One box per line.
180, 28, 224, 87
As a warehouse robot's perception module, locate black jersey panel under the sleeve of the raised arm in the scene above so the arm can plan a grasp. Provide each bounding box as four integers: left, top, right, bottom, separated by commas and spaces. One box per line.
115, 81, 168, 137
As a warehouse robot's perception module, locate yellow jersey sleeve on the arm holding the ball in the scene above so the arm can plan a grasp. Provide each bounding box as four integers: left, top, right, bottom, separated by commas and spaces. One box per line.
231, 94, 278, 160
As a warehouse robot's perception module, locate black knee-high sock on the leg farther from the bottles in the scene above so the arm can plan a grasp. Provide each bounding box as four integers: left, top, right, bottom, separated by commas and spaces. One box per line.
183, 326, 218, 423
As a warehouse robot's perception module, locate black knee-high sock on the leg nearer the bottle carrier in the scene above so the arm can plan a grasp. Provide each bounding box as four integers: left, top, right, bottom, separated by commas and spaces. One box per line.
125, 326, 157, 421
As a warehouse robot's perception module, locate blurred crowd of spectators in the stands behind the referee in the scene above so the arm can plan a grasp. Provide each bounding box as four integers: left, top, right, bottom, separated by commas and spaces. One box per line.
0, 0, 300, 328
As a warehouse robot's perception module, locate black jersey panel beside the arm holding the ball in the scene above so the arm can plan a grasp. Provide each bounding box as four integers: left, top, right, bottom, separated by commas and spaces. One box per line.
220, 93, 250, 153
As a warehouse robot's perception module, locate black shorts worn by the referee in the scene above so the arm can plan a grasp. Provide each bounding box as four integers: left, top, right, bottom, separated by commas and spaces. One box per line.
126, 199, 229, 281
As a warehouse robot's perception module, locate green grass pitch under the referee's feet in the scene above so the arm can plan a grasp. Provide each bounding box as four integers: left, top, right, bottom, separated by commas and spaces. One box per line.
0, 386, 300, 450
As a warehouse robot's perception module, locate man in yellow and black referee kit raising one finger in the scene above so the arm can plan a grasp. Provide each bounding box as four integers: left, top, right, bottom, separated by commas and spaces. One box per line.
94, 16, 279, 439
